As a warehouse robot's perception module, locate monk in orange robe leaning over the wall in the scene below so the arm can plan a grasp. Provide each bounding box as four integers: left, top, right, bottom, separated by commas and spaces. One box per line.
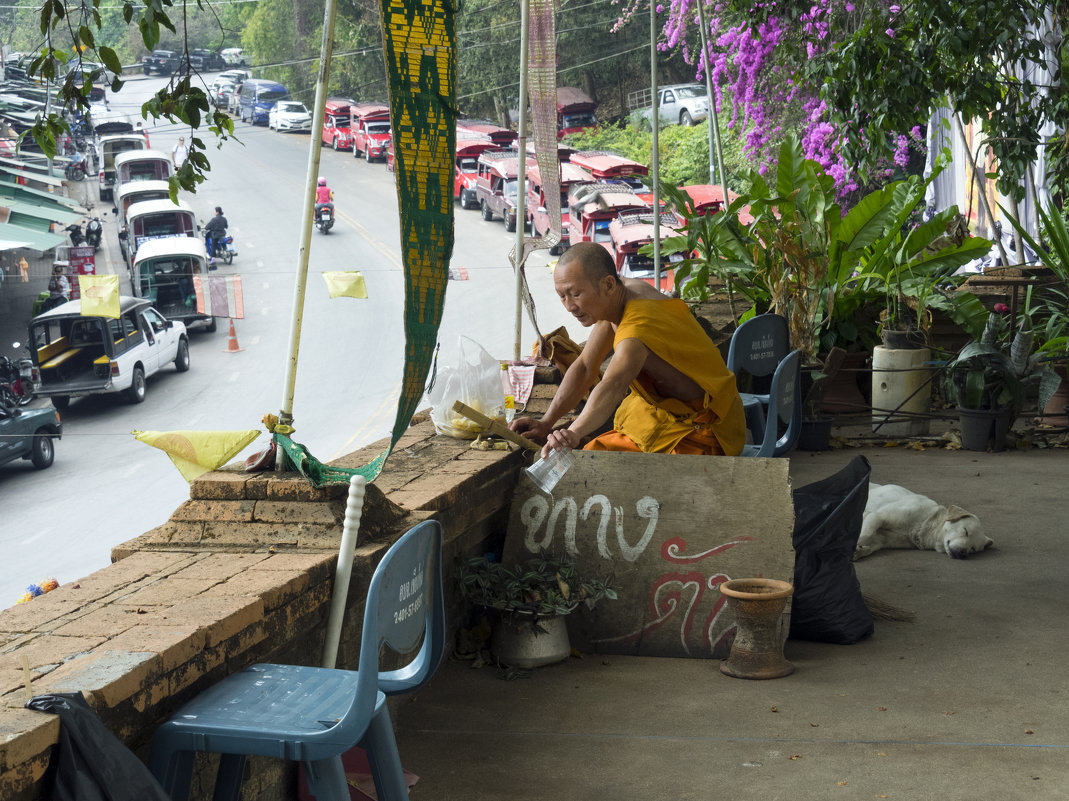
512, 242, 746, 457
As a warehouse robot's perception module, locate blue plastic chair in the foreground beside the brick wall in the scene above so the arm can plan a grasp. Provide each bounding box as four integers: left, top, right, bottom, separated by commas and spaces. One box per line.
151, 521, 446, 801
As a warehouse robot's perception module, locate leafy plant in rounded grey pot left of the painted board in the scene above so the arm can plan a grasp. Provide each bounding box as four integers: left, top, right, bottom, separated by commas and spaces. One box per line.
456, 550, 617, 667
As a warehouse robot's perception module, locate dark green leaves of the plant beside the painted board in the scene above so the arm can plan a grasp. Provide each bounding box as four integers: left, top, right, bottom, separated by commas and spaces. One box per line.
456, 550, 617, 625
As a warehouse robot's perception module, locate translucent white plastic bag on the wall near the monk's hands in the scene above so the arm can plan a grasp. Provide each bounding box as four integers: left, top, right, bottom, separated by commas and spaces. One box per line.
428, 337, 505, 440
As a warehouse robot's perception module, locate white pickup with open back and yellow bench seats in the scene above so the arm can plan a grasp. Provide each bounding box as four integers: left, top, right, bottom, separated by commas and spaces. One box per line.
30, 296, 189, 410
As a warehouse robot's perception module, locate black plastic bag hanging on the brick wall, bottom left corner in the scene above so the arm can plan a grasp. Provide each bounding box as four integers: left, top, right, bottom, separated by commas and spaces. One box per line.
26, 693, 169, 801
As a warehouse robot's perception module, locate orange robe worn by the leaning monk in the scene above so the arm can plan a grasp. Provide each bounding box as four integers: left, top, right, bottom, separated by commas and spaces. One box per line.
586, 298, 746, 456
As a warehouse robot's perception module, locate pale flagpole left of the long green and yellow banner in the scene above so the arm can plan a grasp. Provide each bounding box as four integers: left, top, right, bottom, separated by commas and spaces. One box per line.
276, 0, 338, 440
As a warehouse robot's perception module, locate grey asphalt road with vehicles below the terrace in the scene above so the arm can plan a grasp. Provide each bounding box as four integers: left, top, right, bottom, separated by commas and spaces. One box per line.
0, 78, 584, 607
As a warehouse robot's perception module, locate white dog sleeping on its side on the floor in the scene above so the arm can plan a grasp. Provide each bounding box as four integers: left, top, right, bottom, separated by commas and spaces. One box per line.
854, 483, 994, 559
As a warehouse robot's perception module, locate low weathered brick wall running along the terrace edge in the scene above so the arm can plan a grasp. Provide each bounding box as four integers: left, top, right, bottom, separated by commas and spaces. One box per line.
0, 422, 523, 801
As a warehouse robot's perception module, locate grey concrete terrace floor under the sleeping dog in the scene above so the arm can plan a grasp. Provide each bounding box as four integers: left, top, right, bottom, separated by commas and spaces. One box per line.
394, 448, 1069, 801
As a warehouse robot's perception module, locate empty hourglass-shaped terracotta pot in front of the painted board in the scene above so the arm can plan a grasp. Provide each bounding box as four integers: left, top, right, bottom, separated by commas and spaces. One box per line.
719, 579, 794, 679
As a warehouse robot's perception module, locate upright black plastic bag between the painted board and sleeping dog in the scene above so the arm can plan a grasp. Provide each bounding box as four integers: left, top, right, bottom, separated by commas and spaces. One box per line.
791, 456, 874, 645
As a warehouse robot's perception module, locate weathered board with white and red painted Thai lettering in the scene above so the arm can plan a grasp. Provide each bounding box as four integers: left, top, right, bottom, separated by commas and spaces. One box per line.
503, 451, 794, 659
